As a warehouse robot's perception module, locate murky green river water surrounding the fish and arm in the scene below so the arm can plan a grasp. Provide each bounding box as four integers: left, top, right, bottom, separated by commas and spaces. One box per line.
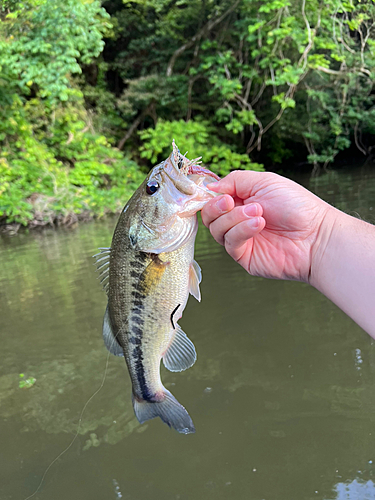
0, 169, 375, 500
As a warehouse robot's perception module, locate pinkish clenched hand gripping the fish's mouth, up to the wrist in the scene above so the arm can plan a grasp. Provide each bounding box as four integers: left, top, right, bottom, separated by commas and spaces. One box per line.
202, 171, 334, 282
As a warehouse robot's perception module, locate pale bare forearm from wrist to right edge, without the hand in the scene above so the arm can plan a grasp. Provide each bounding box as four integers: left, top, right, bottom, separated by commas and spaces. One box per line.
310, 208, 375, 338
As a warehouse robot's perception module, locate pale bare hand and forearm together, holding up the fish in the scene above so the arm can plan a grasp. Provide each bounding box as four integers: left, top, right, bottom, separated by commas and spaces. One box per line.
202, 171, 375, 338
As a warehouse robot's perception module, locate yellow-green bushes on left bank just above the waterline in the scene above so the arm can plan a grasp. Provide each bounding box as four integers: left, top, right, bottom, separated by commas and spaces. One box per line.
0, 99, 143, 224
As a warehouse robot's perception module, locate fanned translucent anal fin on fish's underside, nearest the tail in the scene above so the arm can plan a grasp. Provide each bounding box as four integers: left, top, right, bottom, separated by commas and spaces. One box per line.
163, 325, 197, 372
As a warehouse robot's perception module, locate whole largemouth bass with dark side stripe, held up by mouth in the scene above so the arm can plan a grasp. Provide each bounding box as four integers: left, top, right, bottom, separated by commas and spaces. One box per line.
95, 141, 219, 434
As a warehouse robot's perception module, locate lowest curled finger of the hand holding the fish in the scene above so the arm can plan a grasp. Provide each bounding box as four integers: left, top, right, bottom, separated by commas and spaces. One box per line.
225, 217, 266, 261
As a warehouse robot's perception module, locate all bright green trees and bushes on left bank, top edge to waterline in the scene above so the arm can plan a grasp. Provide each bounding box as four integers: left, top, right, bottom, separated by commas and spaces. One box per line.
0, 0, 143, 225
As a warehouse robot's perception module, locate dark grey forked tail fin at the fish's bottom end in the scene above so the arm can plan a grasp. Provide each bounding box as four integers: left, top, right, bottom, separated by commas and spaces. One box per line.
132, 387, 195, 434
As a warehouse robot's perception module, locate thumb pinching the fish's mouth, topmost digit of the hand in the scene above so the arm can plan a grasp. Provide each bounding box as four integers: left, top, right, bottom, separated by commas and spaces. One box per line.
207, 170, 273, 199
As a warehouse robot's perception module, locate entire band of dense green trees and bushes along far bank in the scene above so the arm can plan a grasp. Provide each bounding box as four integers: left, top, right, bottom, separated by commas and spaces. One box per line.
0, 0, 375, 224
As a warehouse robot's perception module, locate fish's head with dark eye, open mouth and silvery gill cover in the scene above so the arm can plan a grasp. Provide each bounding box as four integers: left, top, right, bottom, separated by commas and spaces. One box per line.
129, 141, 220, 253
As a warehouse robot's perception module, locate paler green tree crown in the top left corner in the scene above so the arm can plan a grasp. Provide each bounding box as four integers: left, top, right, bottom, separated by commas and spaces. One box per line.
0, 0, 112, 101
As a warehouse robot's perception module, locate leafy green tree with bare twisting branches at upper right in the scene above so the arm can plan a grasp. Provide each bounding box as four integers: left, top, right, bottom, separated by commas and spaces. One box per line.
193, 0, 375, 164
